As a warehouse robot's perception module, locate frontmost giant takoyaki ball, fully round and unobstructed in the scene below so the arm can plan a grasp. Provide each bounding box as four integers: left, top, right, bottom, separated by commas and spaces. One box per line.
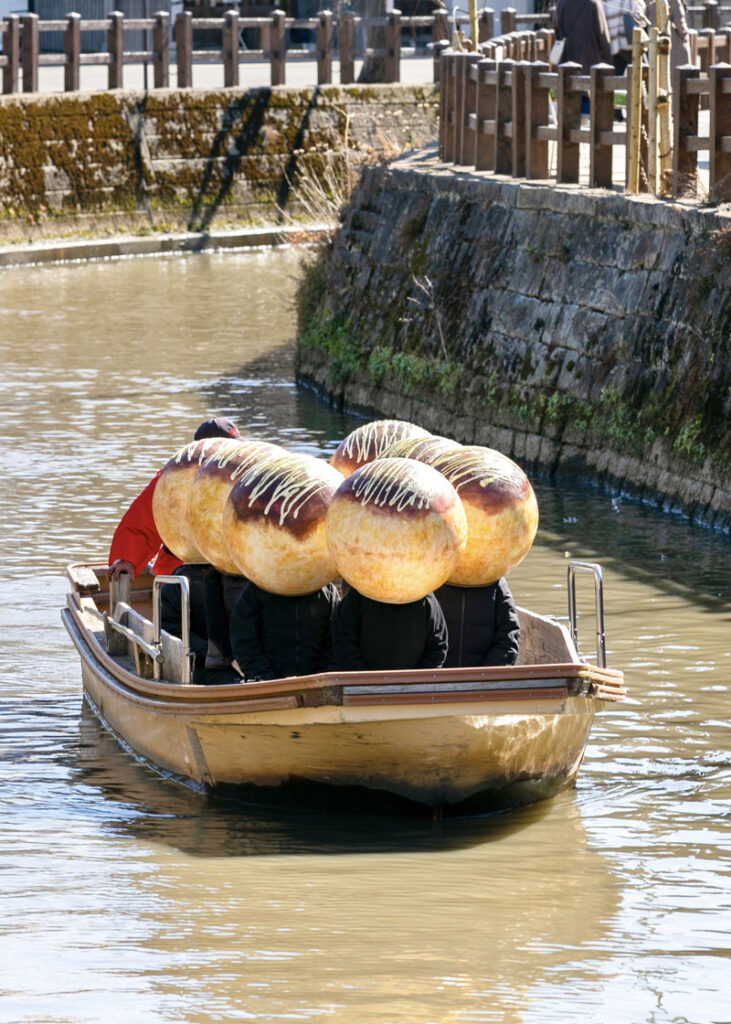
327, 459, 467, 604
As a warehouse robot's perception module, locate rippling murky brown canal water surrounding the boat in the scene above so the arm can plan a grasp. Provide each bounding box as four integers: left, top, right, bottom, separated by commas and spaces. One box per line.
0, 251, 731, 1024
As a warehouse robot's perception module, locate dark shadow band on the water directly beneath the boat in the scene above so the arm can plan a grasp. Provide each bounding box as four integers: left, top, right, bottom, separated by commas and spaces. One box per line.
70, 703, 551, 857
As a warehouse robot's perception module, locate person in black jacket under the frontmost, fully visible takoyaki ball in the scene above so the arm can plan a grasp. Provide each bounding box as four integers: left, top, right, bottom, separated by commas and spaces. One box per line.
333, 587, 446, 672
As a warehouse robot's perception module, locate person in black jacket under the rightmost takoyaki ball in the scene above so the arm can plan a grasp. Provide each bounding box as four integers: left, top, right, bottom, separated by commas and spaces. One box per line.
436, 578, 520, 669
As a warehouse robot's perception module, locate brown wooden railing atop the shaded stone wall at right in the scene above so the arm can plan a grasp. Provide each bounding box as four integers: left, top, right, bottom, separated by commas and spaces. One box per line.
439, 23, 731, 200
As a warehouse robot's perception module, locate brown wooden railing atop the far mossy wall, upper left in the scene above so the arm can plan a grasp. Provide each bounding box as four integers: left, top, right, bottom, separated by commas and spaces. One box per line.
0, 8, 550, 93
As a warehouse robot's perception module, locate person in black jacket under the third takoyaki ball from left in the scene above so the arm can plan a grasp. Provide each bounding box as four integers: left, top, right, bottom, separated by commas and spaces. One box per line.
230, 583, 339, 680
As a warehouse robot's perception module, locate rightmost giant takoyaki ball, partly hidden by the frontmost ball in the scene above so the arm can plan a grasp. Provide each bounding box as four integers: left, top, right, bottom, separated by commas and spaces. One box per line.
432, 445, 539, 587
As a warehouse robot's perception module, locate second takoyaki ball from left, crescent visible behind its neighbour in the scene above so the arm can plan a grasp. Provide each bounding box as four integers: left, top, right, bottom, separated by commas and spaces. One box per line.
187, 438, 283, 575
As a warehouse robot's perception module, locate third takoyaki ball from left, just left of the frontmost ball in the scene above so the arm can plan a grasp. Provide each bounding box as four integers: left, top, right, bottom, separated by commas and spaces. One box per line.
223, 454, 343, 595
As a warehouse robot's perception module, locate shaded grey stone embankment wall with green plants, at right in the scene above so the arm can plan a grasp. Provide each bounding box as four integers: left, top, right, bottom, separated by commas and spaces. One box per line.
297, 153, 731, 529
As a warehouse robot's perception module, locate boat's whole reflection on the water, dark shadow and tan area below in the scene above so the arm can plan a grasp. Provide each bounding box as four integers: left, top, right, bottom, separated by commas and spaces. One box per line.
78, 710, 621, 1024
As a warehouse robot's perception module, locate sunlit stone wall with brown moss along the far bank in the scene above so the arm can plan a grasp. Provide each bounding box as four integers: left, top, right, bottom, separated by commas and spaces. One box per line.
0, 86, 437, 242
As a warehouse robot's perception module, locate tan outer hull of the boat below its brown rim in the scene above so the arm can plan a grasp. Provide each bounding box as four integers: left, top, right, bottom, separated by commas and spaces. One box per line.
75, 630, 602, 807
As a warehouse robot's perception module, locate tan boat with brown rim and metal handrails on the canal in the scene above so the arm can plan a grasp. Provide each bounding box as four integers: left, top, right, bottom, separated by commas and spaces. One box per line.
61, 563, 625, 813
